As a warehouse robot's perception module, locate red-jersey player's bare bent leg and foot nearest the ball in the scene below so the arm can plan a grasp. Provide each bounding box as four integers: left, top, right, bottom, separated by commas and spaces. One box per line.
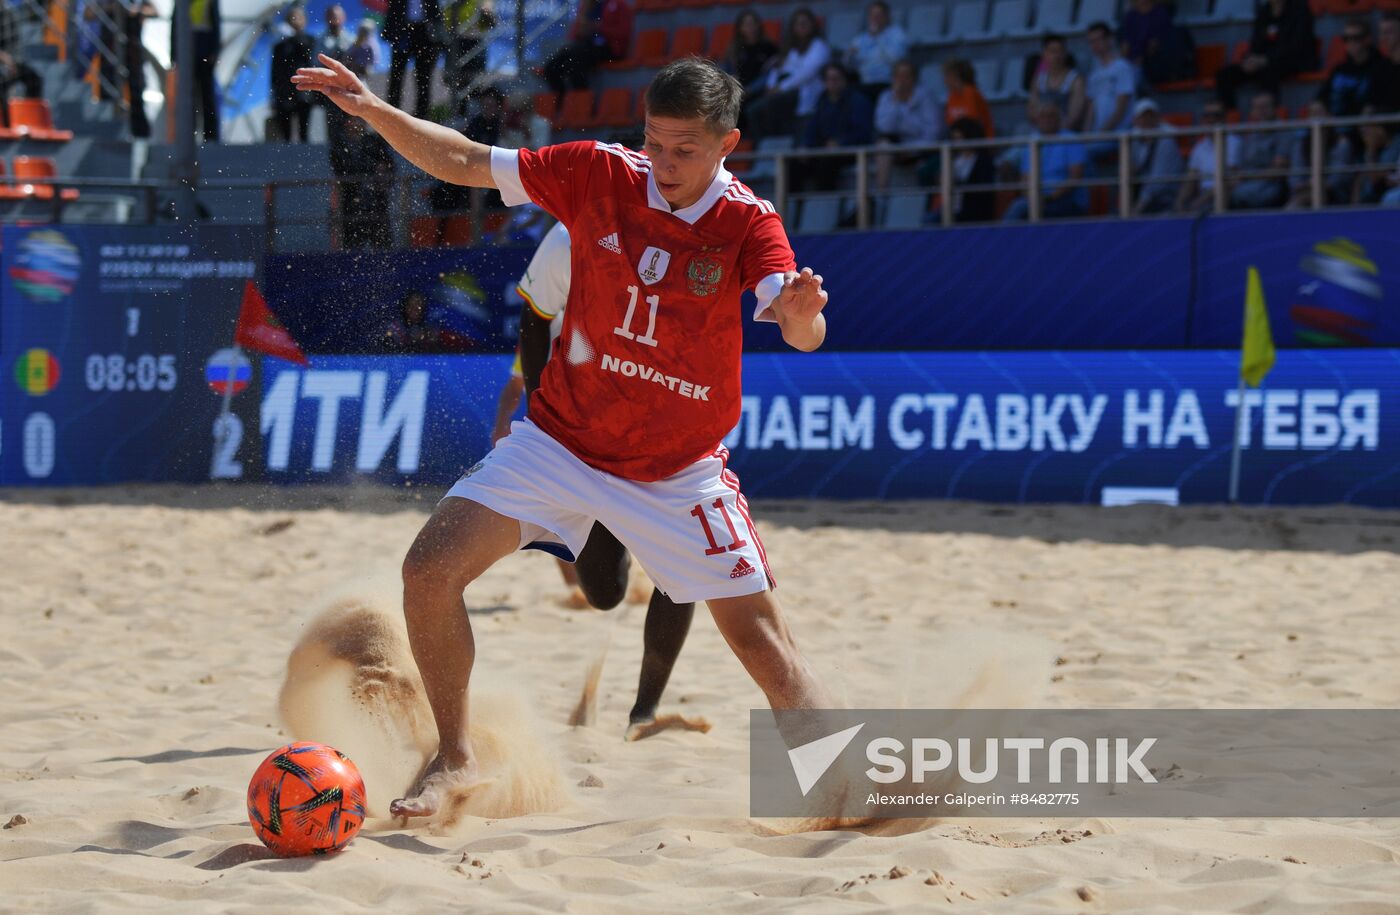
389, 498, 521, 817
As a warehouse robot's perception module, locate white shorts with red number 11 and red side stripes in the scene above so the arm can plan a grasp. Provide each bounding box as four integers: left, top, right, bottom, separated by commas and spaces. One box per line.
442, 420, 774, 603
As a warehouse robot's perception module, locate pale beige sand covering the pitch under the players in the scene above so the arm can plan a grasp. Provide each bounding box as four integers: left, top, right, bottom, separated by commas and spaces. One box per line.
0, 487, 1400, 915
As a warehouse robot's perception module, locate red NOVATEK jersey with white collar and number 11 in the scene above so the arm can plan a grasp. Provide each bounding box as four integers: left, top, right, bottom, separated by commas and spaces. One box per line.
491, 141, 795, 481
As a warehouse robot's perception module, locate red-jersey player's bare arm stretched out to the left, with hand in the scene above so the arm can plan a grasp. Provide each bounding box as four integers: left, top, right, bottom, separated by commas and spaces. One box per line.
291, 55, 496, 187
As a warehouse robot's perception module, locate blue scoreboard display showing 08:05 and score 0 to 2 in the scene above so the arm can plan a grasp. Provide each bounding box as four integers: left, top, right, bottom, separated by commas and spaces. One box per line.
0, 225, 262, 485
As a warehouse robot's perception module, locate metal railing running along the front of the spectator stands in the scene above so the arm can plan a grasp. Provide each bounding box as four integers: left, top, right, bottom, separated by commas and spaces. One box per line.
8, 115, 1400, 243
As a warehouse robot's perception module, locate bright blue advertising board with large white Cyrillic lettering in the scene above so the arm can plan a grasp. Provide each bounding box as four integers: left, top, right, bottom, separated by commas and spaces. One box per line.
259, 350, 1400, 506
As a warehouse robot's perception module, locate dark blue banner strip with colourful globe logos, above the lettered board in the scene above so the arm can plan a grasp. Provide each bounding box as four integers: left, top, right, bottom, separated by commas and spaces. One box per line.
267, 210, 1400, 353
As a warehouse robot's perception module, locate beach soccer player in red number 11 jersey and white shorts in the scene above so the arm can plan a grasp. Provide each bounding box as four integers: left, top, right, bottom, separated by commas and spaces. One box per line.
293, 56, 832, 817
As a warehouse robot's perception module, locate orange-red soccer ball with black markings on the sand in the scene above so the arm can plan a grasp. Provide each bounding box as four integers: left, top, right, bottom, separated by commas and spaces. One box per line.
248, 740, 364, 858
